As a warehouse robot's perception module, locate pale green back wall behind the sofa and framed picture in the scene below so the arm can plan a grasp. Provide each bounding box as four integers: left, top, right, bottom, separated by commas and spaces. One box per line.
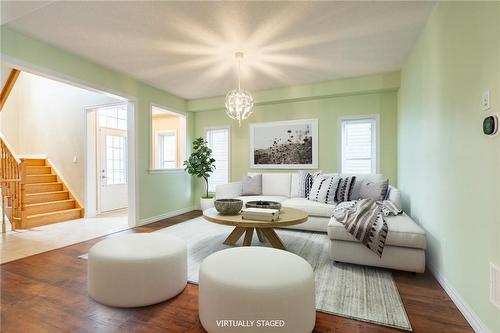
188, 73, 399, 194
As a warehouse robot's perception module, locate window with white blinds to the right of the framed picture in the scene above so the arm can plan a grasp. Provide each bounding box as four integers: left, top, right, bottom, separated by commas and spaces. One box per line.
340, 117, 377, 173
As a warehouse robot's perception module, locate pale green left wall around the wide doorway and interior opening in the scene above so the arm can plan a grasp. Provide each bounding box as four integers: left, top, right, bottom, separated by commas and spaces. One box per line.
0, 27, 194, 219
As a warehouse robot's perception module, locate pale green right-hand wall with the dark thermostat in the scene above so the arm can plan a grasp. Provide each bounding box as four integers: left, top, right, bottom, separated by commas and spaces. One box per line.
398, 2, 500, 332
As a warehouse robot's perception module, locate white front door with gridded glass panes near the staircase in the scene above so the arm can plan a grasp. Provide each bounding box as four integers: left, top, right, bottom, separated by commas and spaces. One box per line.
98, 127, 128, 213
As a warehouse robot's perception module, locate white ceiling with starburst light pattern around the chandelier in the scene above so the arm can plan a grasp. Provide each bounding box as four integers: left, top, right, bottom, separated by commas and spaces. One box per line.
2, 1, 434, 99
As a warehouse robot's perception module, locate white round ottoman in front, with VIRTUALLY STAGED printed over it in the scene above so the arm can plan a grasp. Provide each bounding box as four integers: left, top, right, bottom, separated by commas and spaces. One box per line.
199, 247, 316, 333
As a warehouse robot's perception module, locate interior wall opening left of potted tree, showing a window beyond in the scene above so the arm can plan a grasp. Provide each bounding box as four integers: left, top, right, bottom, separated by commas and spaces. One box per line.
150, 106, 186, 170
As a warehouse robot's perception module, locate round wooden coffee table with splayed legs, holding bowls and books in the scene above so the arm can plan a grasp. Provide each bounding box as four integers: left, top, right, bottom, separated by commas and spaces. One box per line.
203, 207, 308, 250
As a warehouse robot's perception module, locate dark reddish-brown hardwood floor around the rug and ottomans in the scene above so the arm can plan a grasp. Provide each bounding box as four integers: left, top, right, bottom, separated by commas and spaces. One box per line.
0, 211, 473, 333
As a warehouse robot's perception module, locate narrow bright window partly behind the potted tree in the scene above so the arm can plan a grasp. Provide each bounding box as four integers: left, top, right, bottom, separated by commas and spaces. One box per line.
206, 128, 229, 193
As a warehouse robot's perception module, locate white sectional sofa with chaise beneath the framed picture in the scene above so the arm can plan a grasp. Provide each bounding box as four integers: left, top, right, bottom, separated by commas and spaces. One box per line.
216, 172, 426, 273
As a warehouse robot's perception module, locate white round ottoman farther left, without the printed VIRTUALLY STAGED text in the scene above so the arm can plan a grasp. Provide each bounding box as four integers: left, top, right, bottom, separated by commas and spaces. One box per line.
88, 233, 187, 307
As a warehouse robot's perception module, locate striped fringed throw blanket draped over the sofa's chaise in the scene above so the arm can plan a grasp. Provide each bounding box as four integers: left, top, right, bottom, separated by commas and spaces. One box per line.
333, 199, 402, 257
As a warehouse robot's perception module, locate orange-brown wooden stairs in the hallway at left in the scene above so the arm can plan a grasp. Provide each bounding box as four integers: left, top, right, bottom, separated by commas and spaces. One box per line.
18, 158, 83, 229
